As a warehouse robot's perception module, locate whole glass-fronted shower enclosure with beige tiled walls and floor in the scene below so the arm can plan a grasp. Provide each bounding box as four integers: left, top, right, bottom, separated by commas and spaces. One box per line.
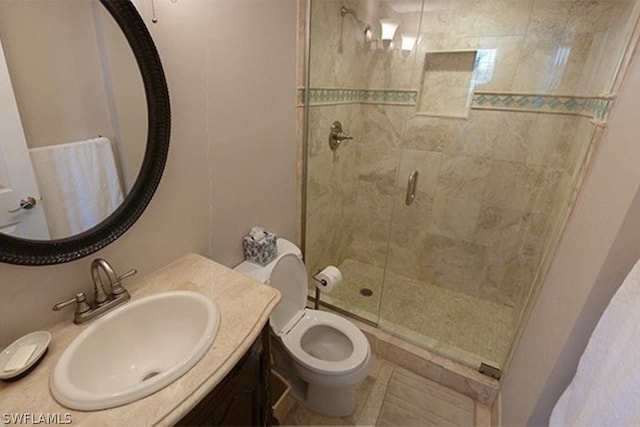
301, 0, 640, 369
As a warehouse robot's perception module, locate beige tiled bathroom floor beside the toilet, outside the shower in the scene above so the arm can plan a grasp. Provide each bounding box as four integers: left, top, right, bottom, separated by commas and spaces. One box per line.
281, 357, 491, 427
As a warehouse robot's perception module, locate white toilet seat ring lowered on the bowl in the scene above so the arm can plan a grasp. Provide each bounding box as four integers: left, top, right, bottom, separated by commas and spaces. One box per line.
280, 309, 369, 375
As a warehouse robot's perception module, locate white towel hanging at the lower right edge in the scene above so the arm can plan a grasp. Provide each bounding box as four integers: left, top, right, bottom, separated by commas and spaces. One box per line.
549, 261, 640, 427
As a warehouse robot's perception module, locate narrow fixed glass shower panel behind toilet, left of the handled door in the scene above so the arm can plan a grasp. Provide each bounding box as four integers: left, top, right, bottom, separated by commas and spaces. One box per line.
305, 0, 421, 324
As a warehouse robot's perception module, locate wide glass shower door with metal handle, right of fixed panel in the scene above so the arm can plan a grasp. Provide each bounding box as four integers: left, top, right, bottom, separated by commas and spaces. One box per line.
378, 0, 639, 368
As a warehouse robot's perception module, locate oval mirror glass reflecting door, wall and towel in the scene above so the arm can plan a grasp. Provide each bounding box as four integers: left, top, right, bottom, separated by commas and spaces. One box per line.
0, 0, 147, 240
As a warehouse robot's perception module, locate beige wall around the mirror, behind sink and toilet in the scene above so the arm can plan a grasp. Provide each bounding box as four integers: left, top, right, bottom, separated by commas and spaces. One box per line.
0, 0, 296, 347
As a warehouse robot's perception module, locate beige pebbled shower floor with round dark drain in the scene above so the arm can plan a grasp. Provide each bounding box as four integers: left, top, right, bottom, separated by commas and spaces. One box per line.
322, 259, 514, 368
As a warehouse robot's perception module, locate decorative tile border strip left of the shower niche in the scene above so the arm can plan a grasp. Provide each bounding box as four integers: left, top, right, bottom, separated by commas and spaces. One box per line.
297, 88, 418, 106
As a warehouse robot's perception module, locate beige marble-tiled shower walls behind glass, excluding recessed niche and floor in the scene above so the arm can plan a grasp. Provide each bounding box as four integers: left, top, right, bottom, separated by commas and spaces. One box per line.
306, 0, 638, 316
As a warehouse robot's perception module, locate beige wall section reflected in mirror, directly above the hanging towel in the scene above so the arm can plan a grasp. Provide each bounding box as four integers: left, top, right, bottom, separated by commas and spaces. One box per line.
0, 1, 113, 148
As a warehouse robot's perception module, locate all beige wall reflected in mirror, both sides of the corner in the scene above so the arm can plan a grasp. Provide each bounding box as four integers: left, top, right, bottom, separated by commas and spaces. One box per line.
0, 1, 147, 193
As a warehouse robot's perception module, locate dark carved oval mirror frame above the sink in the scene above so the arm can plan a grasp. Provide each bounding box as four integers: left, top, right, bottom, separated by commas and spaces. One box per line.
0, 0, 171, 265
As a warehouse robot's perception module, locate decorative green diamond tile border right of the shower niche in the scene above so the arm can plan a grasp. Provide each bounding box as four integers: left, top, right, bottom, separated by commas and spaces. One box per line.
471, 92, 613, 122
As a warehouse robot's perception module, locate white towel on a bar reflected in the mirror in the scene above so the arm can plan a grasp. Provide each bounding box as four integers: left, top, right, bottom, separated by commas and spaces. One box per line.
29, 137, 123, 239
